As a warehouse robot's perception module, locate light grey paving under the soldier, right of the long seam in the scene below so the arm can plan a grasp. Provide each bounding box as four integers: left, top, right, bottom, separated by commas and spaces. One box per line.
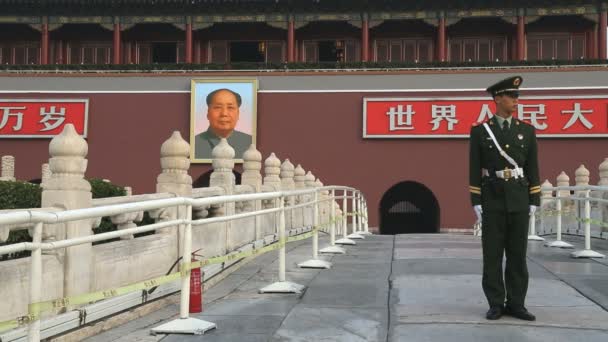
389, 235, 608, 341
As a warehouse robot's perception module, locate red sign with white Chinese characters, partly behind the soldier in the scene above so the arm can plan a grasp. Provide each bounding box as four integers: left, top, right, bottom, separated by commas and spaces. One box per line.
363, 95, 608, 138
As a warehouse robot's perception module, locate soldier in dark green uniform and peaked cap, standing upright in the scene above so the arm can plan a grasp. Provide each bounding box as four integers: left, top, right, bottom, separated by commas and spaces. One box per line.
469, 76, 540, 321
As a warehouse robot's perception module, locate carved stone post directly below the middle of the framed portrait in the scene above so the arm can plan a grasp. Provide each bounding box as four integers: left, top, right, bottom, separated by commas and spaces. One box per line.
209, 138, 236, 252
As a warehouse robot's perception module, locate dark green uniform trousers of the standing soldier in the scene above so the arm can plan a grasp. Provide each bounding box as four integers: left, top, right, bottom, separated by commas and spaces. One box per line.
482, 210, 529, 309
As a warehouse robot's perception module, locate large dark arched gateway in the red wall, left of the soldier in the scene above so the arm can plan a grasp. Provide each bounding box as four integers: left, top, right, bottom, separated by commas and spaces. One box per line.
380, 181, 439, 234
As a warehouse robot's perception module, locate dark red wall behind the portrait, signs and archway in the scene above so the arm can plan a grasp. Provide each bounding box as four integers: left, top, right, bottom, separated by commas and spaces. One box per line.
0, 93, 608, 228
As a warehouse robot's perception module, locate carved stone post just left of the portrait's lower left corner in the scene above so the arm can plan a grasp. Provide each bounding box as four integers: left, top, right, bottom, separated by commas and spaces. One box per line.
150, 131, 192, 240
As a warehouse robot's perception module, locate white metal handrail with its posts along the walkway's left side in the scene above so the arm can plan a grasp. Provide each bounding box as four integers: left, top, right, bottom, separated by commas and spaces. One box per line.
0, 186, 368, 341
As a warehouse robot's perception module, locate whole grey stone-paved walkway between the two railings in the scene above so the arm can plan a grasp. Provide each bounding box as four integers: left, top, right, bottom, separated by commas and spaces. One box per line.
88, 235, 608, 342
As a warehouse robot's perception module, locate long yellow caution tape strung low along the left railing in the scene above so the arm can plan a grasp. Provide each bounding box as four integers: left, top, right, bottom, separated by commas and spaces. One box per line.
0, 218, 346, 332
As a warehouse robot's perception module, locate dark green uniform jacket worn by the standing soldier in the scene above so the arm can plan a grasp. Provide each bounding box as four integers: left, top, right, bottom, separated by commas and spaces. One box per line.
469, 117, 540, 212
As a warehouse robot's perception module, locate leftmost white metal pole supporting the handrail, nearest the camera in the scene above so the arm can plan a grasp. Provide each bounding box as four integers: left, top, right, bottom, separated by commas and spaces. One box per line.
27, 222, 43, 342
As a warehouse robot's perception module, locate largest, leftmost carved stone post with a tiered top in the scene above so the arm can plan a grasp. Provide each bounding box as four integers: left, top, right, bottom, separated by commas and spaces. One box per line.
41, 124, 96, 296
